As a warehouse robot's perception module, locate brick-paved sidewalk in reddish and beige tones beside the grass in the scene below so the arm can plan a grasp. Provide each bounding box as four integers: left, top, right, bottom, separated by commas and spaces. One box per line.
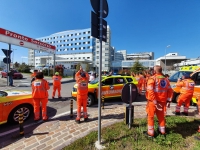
0, 104, 196, 150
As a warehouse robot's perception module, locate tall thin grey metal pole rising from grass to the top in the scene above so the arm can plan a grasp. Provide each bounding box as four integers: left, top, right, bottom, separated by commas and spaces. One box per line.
98, 0, 103, 144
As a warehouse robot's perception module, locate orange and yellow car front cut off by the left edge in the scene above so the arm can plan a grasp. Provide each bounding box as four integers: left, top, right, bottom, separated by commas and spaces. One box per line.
0, 90, 33, 124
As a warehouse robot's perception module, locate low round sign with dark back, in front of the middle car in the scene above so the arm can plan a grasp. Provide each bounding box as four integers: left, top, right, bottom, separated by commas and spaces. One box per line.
121, 83, 138, 104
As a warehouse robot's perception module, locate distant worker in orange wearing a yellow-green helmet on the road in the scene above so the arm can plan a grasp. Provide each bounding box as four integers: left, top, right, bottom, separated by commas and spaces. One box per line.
52, 72, 62, 99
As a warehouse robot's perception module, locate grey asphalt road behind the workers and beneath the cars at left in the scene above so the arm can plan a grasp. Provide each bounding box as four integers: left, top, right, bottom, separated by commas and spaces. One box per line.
0, 74, 146, 138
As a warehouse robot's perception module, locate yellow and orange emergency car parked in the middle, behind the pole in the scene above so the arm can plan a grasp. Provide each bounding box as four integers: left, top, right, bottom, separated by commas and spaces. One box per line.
71, 75, 138, 106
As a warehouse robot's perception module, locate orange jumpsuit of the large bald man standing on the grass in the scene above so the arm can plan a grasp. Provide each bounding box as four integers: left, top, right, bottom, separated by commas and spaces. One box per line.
146, 74, 173, 136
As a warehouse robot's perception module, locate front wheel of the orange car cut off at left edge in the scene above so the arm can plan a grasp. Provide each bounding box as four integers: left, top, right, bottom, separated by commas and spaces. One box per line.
8, 104, 33, 124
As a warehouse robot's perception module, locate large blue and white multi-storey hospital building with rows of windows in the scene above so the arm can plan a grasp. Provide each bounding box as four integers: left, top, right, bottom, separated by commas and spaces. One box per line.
28, 26, 112, 71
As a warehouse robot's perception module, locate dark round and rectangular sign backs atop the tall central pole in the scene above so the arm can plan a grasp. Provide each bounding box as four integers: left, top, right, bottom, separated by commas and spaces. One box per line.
90, 0, 108, 42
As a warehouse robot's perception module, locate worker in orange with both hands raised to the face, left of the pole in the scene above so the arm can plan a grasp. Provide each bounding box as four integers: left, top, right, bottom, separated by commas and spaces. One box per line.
75, 66, 89, 123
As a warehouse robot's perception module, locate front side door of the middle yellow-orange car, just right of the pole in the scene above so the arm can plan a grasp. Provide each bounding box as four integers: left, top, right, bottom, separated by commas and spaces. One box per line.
102, 77, 113, 98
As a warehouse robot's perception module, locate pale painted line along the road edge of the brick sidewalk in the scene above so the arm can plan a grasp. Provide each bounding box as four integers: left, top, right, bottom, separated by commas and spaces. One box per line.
0, 109, 76, 137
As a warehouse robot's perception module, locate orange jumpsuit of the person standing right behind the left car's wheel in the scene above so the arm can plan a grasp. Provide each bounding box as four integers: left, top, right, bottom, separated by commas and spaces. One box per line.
32, 79, 50, 120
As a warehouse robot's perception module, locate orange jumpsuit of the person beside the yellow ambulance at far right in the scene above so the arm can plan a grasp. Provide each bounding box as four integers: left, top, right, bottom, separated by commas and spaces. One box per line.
176, 79, 195, 113
